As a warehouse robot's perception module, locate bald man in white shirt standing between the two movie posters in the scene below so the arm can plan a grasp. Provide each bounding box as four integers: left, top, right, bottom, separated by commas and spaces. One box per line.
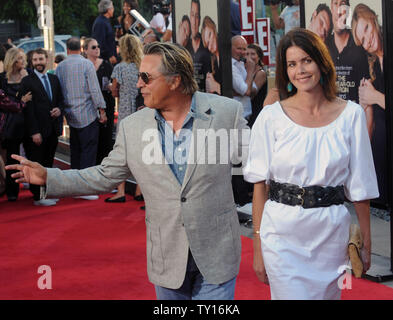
232, 36, 257, 120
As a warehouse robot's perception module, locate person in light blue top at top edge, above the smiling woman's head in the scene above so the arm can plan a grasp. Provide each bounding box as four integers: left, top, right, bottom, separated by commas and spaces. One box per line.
270, 0, 300, 33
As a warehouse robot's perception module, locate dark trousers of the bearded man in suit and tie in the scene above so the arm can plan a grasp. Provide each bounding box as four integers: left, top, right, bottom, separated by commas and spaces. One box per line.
24, 134, 59, 201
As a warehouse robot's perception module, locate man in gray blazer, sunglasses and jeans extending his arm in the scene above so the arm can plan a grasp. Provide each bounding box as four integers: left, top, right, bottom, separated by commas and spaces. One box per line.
7, 42, 249, 300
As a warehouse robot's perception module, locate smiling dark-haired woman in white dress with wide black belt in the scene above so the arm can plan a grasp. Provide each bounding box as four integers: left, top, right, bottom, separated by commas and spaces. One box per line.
244, 29, 378, 299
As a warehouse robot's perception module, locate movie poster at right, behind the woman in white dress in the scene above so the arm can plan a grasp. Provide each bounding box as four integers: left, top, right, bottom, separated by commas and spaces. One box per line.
304, 0, 389, 205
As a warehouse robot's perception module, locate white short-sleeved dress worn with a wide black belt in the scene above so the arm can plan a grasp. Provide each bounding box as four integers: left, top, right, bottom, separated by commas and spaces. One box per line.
244, 101, 379, 300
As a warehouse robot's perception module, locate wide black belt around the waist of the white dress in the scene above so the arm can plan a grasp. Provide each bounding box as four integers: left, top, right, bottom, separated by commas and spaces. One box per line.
269, 180, 345, 209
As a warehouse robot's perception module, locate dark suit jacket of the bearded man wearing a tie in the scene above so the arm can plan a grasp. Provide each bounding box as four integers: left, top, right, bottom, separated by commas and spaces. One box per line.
21, 72, 64, 138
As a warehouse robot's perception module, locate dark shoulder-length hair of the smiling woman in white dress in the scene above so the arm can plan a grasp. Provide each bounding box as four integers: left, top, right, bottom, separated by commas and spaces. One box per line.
276, 28, 337, 101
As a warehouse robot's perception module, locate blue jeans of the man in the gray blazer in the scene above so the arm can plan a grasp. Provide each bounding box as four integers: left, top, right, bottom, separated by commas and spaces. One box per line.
155, 252, 236, 300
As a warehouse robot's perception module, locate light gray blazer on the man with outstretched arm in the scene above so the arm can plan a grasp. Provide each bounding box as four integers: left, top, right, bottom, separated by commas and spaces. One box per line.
46, 92, 249, 289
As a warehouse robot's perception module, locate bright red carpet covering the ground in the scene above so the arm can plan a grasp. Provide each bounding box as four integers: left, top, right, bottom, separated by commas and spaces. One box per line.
0, 191, 393, 300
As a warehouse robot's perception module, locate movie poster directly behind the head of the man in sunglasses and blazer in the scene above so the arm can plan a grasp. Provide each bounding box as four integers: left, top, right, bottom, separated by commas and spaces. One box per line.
174, 0, 223, 94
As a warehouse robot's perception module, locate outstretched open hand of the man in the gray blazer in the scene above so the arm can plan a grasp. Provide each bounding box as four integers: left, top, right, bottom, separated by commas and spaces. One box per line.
5, 154, 47, 186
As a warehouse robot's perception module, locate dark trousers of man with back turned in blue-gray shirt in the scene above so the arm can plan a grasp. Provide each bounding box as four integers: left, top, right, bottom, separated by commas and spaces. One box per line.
70, 120, 99, 169
